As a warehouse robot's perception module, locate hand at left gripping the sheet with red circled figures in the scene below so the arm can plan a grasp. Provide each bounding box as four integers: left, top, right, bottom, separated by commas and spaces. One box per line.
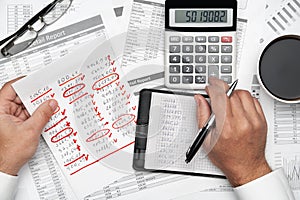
0, 79, 58, 175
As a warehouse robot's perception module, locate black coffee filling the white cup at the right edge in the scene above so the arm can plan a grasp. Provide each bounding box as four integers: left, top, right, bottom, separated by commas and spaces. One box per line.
259, 36, 300, 101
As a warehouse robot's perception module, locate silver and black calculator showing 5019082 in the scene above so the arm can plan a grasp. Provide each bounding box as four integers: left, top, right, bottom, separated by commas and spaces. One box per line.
165, 0, 237, 89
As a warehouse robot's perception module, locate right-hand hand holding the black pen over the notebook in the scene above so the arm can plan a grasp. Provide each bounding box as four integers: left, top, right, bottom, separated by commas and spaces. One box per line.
195, 78, 271, 187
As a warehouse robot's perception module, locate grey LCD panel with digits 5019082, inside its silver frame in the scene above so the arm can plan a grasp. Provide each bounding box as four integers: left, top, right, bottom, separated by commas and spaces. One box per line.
175, 10, 228, 23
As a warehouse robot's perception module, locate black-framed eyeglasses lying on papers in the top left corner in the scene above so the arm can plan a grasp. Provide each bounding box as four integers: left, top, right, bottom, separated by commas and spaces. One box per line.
0, 0, 73, 57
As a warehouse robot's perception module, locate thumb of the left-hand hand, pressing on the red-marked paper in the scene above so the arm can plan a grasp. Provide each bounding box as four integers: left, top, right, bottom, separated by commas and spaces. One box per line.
25, 99, 58, 133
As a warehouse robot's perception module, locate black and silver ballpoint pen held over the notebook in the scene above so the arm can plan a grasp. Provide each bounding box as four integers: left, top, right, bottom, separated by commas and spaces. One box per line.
185, 80, 238, 163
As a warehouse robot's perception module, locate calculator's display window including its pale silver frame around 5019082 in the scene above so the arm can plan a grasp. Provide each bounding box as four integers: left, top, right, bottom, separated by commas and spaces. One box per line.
169, 8, 233, 27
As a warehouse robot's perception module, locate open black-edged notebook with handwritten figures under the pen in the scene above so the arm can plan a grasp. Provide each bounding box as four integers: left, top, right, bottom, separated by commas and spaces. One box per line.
133, 89, 224, 177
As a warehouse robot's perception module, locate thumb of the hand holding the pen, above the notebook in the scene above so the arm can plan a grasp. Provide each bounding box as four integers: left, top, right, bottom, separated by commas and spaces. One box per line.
194, 95, 211, 128
